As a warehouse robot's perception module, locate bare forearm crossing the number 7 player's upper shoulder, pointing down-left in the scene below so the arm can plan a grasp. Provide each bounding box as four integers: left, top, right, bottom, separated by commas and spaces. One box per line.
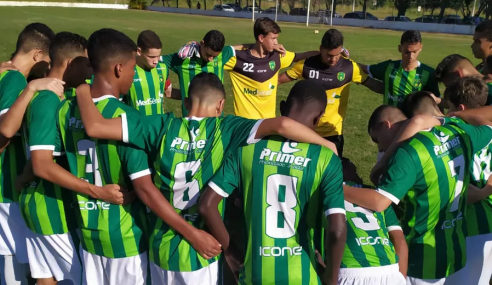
370, 115, 442, 185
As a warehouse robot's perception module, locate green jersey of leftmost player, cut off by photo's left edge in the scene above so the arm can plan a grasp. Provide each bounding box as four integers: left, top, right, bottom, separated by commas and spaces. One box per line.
0, 70, 27, 203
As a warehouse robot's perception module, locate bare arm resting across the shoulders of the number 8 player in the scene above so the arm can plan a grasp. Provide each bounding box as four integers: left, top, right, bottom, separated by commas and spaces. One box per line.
255, 117, 338, 155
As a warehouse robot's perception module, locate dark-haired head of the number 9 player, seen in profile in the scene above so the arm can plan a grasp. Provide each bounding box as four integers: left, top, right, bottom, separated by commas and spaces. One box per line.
87, 29, 137, 94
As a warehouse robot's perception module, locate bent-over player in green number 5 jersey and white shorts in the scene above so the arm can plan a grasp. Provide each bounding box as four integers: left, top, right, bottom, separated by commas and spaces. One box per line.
337, 159, 408, 285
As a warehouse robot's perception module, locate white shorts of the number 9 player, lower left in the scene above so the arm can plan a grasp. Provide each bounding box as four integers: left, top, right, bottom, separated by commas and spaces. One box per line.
80, 248, 149, 285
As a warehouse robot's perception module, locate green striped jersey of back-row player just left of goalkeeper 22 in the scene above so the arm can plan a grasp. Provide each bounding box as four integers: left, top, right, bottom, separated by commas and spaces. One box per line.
160, 46, 235, 117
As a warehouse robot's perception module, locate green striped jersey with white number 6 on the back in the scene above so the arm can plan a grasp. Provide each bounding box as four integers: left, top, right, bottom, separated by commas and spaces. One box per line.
122, 113, 261, 272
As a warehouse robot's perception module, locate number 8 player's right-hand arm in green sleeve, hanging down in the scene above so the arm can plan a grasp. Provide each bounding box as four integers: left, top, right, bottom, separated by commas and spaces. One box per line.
319, 157, 347, 284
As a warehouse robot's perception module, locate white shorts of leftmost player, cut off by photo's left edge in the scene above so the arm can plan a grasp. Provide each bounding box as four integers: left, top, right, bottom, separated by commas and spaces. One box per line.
0, 203, 29, 263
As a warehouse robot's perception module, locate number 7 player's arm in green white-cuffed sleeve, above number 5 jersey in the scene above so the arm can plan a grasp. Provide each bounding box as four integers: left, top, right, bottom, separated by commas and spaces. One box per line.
343, 148, 417, 212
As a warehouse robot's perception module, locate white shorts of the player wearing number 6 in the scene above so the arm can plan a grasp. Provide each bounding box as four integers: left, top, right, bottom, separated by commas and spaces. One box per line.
150, 261, 219, 285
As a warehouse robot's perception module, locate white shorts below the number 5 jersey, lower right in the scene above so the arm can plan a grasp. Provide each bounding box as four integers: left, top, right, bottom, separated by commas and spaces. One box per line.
337, 264, 407, 285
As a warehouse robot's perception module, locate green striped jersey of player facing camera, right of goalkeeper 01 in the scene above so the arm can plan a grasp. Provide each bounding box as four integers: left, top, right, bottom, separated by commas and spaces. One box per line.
368, 60, 441, 108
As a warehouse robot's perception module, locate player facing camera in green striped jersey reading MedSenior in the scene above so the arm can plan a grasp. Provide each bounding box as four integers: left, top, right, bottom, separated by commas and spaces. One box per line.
125, 30, 172, 116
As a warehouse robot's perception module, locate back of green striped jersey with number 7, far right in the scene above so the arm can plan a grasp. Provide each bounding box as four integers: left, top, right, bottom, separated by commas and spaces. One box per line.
399, 124, 472, 279
